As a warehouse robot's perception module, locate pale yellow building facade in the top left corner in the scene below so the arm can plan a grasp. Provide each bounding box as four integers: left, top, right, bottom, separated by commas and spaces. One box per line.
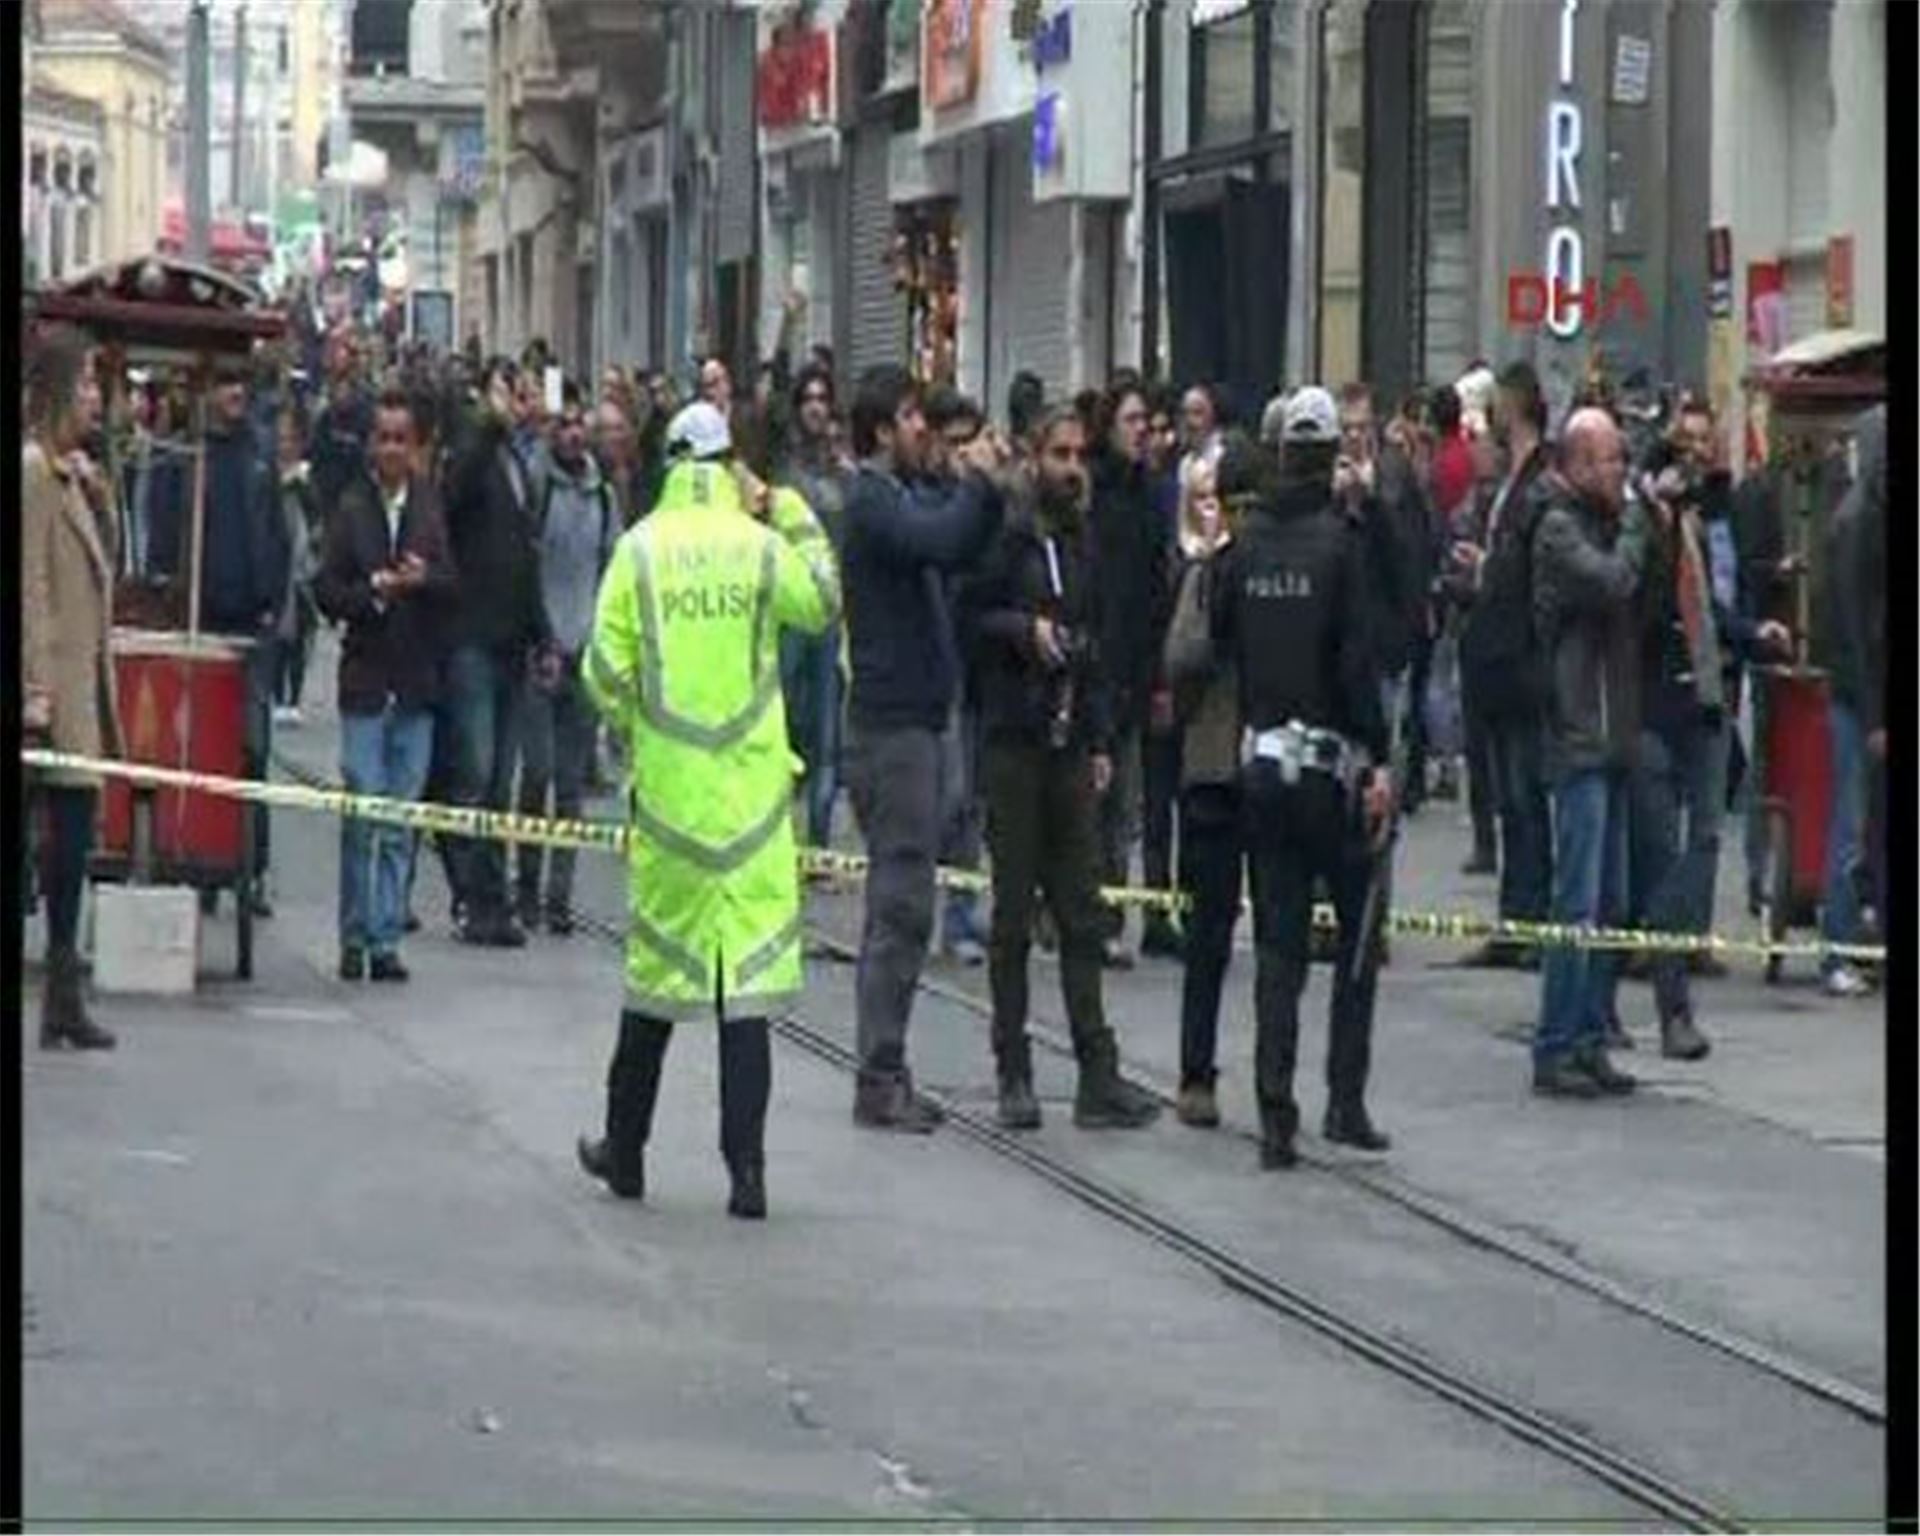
29, 0, 169, 267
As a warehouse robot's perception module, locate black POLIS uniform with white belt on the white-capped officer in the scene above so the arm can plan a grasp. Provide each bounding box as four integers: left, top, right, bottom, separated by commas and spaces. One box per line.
1212, 422, 1388, 1167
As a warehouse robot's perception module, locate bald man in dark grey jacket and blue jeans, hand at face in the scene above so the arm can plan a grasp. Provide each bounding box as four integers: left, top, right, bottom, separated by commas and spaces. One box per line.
1532, 409, 1659, 1098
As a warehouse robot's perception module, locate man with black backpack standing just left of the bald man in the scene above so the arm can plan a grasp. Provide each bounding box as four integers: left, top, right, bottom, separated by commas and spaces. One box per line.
1452, 361, 1553, 968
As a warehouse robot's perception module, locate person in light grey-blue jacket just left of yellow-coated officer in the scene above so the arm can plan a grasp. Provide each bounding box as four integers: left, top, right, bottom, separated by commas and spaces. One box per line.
515, 386, 622, 939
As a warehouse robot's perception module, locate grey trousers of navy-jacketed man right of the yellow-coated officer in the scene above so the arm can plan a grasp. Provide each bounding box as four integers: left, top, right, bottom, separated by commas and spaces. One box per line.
847, 726, 943, 1079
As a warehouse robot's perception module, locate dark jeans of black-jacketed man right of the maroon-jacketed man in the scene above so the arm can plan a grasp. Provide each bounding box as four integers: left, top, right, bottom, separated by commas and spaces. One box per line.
447, 645, 522, 918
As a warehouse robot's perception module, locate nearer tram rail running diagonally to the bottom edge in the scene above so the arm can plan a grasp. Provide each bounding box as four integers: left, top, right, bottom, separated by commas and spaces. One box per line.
556, 910, 1747, 1532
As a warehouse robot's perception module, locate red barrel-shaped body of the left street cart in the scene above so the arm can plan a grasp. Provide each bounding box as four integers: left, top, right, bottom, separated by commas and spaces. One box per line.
100, 630, 253, 885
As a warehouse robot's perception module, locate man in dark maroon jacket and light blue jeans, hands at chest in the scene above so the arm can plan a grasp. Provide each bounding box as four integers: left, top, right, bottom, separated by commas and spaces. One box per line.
315, 394, 453, 981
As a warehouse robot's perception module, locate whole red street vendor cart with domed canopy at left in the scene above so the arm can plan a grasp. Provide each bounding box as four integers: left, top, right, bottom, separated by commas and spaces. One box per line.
33, 257, 286, 979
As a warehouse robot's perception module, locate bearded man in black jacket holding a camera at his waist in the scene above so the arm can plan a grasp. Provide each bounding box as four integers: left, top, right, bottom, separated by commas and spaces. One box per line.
962, 407, 1158, 1131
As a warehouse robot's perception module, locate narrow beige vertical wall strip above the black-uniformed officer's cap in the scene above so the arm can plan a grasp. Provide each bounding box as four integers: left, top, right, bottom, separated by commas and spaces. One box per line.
1313, 0, 1367, 384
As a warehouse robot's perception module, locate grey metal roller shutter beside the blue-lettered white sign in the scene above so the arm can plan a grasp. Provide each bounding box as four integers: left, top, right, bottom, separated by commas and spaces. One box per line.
987, 127, 1073, 401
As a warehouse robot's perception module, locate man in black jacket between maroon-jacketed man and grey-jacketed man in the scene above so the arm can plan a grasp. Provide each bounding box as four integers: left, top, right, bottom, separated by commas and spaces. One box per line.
445, 359, 553, 948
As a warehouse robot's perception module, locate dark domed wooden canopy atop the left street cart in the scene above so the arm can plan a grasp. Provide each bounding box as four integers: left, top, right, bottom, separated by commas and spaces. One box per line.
29, 255, 286, 355
